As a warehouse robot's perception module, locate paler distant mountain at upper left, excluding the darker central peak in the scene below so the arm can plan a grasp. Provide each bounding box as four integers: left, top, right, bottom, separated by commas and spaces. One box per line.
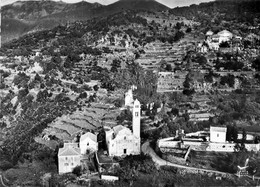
2, 1, 103, 43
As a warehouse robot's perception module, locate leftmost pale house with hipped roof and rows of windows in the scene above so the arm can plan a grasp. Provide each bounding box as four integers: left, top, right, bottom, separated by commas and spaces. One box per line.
58, 143, 81, 174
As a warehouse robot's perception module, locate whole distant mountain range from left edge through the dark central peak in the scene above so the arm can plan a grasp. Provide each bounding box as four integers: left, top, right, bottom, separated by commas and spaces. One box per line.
2, 0, 169, 42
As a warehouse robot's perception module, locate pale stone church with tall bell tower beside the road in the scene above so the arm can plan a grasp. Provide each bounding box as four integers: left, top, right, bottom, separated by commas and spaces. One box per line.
106, 99, 141, 156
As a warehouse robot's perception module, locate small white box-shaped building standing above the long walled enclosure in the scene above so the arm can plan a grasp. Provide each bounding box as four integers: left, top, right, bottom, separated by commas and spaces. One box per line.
210, 126, 227, 143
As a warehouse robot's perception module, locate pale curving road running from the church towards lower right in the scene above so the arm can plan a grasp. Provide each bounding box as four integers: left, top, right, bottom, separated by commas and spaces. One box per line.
142, 142, 233, 175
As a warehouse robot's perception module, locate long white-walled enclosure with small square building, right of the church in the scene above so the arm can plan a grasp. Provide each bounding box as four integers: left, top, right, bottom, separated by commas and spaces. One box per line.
157, 126, 260, 156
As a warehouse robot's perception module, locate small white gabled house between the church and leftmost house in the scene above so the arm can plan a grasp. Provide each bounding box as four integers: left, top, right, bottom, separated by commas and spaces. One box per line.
79, 132, 98, 154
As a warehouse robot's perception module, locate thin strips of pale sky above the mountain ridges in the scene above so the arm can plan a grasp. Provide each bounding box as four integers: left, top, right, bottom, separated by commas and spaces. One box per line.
0, 0, 212, 8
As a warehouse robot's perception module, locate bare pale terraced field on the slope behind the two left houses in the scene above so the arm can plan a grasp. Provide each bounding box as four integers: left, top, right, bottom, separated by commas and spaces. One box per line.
43, 103, 120, 140
